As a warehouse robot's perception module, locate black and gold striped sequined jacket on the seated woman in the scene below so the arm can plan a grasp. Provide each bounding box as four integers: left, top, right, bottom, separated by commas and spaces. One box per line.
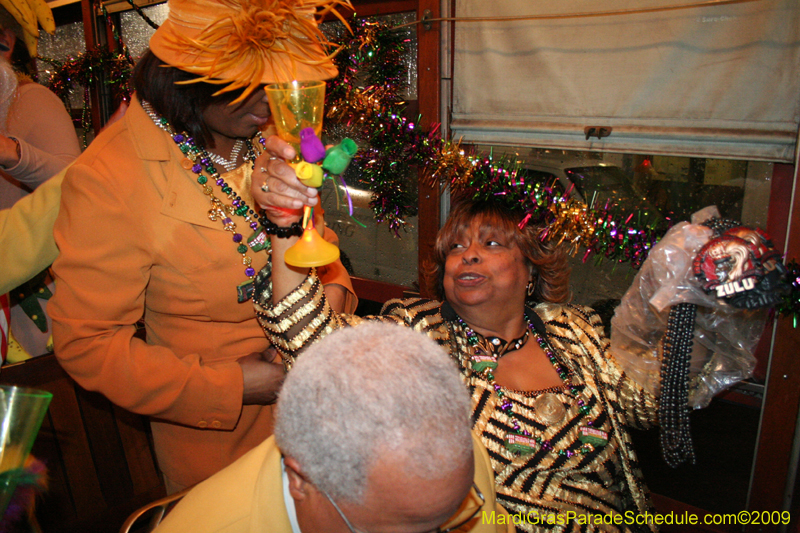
254, 272, 657, 532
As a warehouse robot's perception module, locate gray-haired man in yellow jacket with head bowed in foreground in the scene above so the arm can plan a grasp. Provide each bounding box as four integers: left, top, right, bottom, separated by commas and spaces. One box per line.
157, 323, 512, 533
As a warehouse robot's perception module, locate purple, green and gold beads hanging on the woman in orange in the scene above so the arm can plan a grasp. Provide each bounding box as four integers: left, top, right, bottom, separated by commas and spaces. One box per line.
141, 100, 269, 303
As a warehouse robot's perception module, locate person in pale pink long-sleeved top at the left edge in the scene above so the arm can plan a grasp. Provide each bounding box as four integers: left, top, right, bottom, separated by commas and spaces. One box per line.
0, 9, 81, 361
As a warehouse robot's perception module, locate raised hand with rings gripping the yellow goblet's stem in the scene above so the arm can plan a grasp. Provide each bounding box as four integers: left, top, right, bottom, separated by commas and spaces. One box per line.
251, 135, 319, 227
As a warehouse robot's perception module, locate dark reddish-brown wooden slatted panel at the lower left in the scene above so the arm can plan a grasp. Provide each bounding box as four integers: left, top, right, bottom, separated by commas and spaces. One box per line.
0, 355, 166, 533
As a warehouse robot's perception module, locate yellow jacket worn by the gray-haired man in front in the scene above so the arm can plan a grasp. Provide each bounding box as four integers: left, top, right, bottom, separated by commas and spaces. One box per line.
156, 435, 513, 533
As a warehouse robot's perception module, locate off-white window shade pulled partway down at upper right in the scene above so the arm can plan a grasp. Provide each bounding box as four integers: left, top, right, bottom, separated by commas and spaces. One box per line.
450, 0, 800, 162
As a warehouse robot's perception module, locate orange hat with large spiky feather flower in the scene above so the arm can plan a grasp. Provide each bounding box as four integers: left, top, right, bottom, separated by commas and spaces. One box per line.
150, 0, 353, 100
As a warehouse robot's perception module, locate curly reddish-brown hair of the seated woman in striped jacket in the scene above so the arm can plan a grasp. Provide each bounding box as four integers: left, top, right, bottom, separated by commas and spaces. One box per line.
425, 200, 570, 306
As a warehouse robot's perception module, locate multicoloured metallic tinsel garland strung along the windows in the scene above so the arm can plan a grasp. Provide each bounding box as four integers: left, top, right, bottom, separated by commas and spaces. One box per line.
40, 13, 800, 320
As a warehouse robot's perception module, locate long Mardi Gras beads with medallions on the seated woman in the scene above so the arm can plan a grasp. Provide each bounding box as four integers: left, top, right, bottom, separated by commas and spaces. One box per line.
456, 315, 608, 458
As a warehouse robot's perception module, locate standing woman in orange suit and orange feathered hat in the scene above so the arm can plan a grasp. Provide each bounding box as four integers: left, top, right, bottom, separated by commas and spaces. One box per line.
50, 0, 355, 493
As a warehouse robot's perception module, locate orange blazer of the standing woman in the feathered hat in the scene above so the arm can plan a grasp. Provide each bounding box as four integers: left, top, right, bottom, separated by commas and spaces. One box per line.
48, 99, 355, 486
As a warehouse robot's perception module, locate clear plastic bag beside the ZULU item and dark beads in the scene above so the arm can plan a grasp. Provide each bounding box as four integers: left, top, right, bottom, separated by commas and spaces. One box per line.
611, 206, 767, 408
